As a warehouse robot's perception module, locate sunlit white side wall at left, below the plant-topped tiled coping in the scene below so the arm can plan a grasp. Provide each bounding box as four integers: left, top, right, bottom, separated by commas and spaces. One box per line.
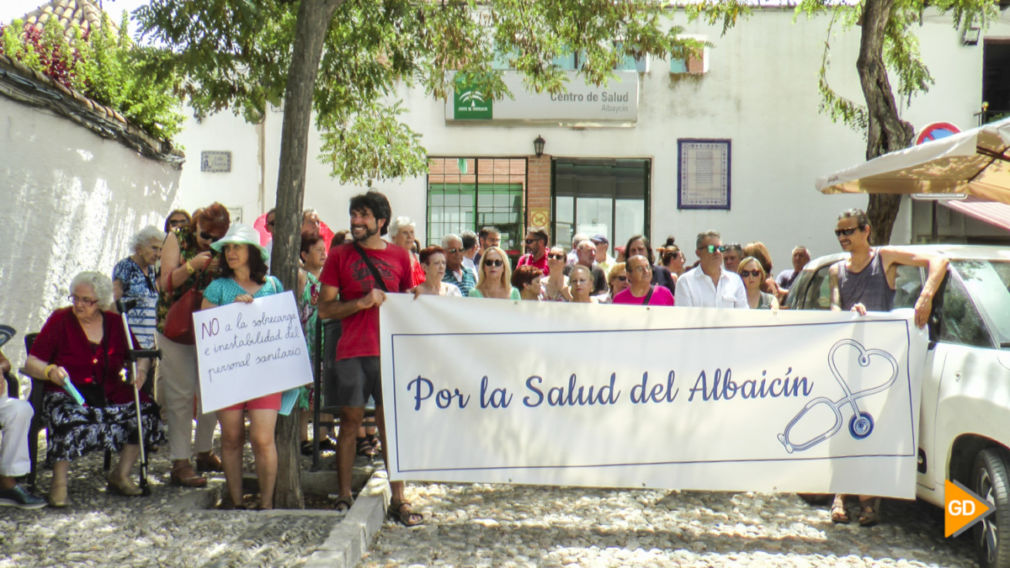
0, 96, 180, 362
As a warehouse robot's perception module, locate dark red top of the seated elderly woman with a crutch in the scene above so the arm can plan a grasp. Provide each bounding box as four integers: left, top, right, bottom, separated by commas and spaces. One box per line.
29, 307, 147, 404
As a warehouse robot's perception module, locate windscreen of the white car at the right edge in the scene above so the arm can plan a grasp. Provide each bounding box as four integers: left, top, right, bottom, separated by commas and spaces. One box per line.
952, 260, 1010, 347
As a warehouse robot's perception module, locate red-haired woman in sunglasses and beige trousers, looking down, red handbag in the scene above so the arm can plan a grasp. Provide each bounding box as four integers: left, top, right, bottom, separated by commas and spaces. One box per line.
157, 203, 231, 487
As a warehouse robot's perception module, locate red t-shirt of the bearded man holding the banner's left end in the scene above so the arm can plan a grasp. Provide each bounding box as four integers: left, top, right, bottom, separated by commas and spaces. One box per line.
319, 243, 411, 360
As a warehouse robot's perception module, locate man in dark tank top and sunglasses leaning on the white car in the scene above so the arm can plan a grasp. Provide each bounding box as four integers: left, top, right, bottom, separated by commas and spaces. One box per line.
829, 209, 947, 527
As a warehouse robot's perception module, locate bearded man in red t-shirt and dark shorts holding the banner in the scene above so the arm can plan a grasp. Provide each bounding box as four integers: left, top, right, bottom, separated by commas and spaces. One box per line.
318, 191, 422, 527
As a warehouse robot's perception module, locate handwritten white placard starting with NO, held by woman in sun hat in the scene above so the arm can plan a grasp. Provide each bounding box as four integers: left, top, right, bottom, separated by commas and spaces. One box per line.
193, 291, 312, 412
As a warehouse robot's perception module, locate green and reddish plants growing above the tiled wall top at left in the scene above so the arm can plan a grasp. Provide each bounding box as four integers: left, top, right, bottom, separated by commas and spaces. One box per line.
0, 12, 183, 139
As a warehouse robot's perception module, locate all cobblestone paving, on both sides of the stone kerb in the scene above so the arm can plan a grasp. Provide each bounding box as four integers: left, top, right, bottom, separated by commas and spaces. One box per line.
0, 444, 975, 568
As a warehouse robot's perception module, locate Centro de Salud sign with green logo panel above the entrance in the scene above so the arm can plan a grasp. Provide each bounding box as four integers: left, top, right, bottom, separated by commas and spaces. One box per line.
445, 71, 638, 123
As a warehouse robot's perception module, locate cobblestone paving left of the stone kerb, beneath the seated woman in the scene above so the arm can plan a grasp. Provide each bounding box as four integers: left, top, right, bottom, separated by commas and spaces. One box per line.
0, 449, 340, 568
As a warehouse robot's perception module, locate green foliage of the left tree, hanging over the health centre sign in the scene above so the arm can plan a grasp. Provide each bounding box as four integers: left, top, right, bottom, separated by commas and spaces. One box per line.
136, 0, 702, 182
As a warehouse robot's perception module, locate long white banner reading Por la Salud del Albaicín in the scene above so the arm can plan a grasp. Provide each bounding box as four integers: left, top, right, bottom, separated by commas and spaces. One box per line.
380, 294, 926, 498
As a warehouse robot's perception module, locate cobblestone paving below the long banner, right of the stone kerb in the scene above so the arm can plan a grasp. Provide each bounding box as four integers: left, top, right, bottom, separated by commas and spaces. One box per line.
362, 484, 976, 568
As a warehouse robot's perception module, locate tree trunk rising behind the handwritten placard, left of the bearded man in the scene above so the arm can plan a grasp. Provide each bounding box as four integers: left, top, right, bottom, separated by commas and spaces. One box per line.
271, 0, 343, 508
